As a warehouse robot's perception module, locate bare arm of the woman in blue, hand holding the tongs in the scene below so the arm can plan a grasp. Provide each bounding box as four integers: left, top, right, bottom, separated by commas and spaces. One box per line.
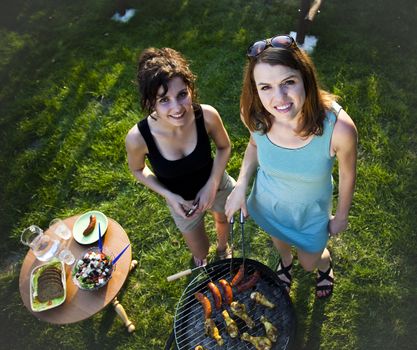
225, 136, 258, 221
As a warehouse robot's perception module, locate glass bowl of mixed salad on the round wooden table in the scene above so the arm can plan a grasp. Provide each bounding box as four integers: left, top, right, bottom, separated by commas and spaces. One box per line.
72, 247, 114, 290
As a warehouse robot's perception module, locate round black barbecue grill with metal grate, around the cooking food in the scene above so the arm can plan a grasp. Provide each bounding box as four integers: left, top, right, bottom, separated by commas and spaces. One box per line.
166, 258, 296, 350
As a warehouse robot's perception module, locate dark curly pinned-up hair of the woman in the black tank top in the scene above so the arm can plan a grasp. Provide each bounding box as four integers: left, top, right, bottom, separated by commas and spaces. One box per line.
137, 47, 197, 113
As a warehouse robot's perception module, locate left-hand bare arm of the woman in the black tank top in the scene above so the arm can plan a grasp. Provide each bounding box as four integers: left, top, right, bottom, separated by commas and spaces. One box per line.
125, 121, 188, 218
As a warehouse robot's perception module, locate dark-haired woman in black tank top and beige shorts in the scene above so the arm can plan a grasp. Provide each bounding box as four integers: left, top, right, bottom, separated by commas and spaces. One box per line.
126, 48, 234, 265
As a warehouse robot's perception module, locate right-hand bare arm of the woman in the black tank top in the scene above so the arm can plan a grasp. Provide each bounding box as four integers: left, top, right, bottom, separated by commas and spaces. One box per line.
195, 105, 231, 211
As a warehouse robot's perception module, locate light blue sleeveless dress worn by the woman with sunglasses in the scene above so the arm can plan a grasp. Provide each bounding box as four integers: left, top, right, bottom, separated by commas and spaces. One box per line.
247, 103, 341, 253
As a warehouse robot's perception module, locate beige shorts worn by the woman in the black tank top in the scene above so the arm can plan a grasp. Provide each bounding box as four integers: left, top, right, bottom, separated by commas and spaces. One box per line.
167, 172, 236, 233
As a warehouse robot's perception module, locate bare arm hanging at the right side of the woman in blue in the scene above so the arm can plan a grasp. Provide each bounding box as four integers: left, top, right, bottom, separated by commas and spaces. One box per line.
329, 110, 358, 235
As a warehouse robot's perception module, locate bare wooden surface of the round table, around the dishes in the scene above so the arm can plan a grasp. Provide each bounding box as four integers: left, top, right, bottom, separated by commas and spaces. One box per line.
19, 215, 132, 324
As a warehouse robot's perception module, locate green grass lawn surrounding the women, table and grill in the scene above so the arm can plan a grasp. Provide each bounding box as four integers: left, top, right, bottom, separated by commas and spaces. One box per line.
0, 0, 417, 350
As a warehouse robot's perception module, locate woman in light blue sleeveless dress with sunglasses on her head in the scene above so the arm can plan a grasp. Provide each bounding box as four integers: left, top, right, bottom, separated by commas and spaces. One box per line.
226, 35, 357, 298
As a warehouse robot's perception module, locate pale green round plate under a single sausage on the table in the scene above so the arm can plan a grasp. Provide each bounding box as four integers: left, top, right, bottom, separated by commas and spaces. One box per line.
72, 210, 108, 244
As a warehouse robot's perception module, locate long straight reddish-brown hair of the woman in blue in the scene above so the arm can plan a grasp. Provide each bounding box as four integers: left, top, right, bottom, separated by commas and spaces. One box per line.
240, 45, 337, 137
